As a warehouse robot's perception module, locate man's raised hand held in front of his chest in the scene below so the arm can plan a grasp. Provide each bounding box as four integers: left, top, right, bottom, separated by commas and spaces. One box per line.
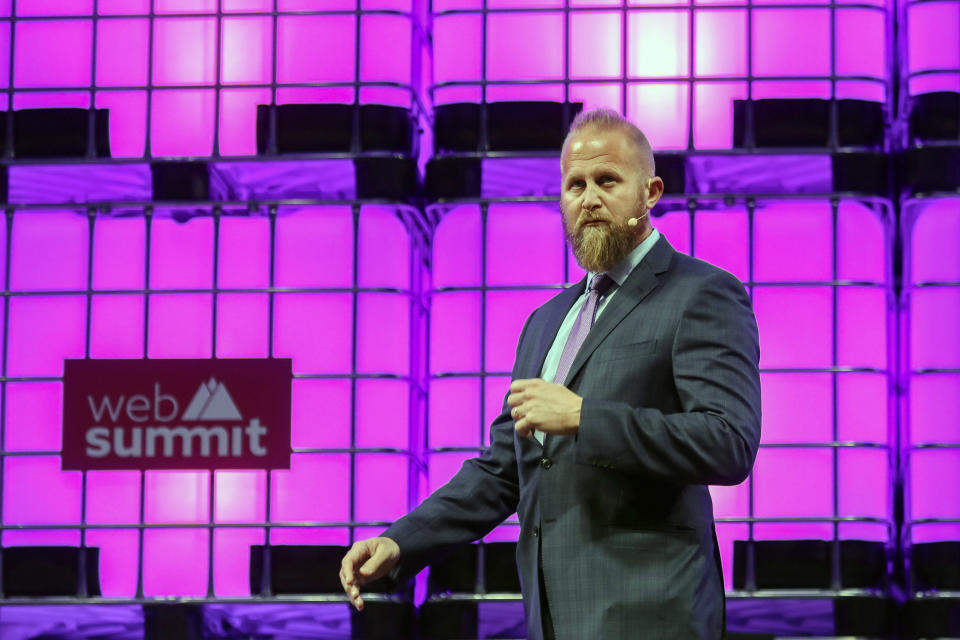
507, 378, 583, 438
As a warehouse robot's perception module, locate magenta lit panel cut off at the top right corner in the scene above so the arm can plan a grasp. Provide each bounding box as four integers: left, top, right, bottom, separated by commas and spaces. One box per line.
900, 0, 960, 96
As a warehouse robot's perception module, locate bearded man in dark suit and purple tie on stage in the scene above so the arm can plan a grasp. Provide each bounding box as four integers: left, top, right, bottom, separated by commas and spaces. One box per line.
340, 110, 760, 640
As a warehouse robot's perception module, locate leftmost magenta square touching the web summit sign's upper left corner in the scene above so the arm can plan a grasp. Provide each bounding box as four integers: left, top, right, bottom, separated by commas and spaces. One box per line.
7, 296, 87, 377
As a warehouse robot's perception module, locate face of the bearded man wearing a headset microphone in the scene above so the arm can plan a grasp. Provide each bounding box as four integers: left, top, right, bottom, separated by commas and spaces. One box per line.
560, 127, 663, 272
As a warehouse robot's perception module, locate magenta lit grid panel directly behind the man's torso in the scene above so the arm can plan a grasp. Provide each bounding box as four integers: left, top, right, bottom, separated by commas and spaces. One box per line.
428, 198, 896, 588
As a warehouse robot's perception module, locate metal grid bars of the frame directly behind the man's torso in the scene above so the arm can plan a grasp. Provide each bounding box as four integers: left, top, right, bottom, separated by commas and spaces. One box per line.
426, 194, 899, 597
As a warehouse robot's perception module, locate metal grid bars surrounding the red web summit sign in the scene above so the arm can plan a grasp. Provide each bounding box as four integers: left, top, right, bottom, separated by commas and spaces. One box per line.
0, 200, 429, 602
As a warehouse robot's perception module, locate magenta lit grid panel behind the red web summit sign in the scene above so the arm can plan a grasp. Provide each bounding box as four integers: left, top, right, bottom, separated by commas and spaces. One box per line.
0, 206, 426, 598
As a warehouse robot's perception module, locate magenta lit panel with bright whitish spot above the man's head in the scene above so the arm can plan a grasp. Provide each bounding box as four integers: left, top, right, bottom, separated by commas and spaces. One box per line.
432, 0, 888, 150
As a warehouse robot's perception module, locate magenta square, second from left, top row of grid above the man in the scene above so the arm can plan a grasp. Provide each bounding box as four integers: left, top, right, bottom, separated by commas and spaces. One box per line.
486, 13, 563, 80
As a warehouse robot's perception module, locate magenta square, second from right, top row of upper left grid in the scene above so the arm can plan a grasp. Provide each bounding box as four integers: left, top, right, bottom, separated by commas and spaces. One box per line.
277, 15, 356, 83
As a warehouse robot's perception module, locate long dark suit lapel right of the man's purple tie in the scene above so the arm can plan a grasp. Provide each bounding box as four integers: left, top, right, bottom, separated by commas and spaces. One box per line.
564, 236, 676, 387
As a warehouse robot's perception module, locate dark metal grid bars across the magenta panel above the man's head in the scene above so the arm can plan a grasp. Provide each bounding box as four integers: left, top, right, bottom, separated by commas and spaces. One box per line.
427, 0, 896, 155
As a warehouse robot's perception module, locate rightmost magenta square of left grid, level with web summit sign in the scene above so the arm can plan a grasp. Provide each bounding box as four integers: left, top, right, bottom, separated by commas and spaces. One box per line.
356, 379, 410, 450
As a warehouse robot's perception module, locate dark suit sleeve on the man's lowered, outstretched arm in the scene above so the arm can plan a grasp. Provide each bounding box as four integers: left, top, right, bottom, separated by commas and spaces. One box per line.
383, 318, 530, 580
